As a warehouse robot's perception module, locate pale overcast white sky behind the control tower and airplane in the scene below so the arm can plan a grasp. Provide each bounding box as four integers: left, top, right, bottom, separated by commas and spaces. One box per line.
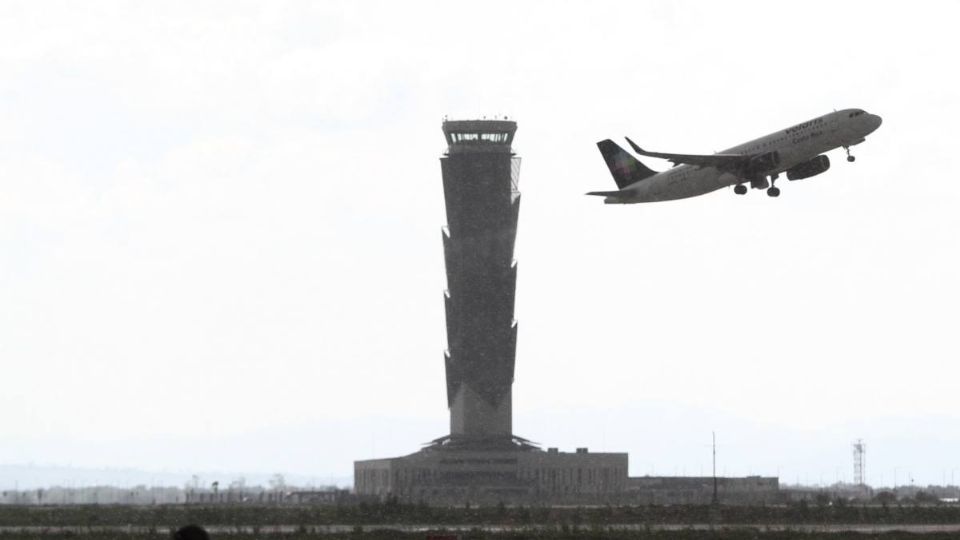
0, 1, 960, 490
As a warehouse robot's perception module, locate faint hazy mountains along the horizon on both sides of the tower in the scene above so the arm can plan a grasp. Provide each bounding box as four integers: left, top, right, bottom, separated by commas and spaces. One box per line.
7, 402, 960, 489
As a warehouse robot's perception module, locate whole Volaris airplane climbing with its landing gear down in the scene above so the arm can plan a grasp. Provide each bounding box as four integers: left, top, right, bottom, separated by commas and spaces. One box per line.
587, 109, 883, 204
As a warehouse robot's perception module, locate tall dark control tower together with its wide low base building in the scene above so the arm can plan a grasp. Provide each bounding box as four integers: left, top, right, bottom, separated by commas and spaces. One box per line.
354, 119, 776, 504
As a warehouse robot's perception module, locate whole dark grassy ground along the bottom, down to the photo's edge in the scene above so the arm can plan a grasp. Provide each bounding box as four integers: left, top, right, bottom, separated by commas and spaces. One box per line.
0, 501, 960, 540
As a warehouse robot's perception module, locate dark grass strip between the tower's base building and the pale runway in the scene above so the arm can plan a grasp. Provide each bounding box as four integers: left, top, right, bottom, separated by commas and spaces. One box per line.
0, 502, 960, 528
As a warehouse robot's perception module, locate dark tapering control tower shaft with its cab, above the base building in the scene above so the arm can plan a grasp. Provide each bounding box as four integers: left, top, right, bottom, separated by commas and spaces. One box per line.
440, 120, 520, 439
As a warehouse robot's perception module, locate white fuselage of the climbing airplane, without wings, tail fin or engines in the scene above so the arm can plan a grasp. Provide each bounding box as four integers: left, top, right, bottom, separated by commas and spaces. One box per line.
604, 109, 882, 204
